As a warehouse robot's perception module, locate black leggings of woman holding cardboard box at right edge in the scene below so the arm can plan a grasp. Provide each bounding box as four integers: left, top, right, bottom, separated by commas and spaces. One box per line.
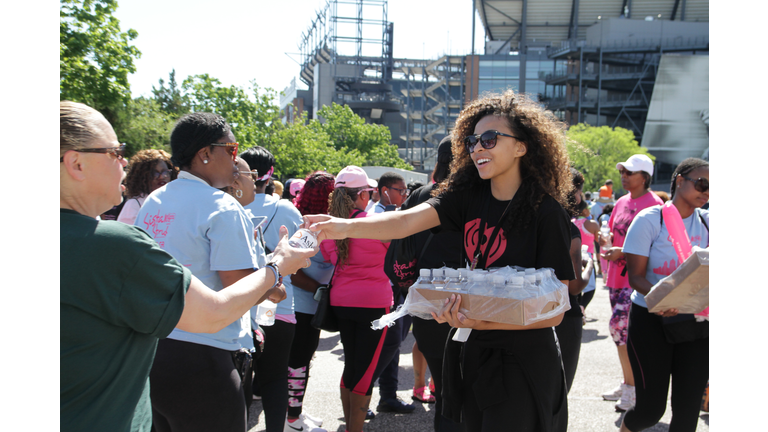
624, 303, 709, 432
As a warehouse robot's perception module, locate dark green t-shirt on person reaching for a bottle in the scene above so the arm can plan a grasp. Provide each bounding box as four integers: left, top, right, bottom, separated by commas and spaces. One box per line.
59, 209, 191, 431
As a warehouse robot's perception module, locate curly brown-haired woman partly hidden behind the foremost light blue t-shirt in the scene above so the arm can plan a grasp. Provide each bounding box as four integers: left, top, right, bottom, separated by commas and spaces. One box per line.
117, 149, 176, 225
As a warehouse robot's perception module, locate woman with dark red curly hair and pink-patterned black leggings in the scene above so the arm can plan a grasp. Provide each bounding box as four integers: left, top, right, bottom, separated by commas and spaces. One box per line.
286, 171, 335, 432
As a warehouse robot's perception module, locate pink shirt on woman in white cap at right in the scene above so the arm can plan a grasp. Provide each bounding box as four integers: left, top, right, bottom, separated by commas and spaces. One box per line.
605, 192, 664, 288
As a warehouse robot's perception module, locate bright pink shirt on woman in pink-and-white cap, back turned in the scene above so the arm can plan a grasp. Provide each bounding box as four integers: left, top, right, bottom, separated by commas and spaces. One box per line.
320, 212, 393, 308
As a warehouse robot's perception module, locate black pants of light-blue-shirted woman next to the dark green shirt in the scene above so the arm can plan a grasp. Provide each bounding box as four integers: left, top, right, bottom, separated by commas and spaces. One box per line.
149, 339, 246, 432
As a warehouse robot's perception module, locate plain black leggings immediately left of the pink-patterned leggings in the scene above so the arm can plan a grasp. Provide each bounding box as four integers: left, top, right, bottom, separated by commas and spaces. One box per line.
253, 319, 295, 432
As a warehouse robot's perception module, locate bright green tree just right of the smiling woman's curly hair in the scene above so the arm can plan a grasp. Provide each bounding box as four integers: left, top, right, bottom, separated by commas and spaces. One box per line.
568, 123, 655, 191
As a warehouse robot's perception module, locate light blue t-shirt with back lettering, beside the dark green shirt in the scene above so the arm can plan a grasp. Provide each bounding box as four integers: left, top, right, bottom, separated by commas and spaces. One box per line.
134, 171, 257, 351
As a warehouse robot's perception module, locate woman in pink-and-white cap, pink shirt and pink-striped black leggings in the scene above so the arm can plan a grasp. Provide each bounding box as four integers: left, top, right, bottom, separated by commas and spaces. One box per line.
320, 166, 393, 432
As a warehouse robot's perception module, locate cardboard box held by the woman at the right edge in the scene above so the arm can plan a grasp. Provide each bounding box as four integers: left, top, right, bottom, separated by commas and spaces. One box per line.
645, 249, 709, 314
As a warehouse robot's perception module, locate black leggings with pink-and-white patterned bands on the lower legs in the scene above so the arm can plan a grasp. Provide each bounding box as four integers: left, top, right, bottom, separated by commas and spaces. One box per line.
288, 312, 320, 417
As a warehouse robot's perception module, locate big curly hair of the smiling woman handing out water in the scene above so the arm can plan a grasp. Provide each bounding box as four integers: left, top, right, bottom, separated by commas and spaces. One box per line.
432, 89, 572, 232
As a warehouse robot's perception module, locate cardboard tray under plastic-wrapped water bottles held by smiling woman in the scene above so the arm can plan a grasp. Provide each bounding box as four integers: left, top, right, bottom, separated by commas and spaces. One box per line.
414, 285, 571, 325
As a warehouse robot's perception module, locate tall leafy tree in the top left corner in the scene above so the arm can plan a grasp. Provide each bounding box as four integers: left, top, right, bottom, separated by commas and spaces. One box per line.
59, 0, 141, 122
